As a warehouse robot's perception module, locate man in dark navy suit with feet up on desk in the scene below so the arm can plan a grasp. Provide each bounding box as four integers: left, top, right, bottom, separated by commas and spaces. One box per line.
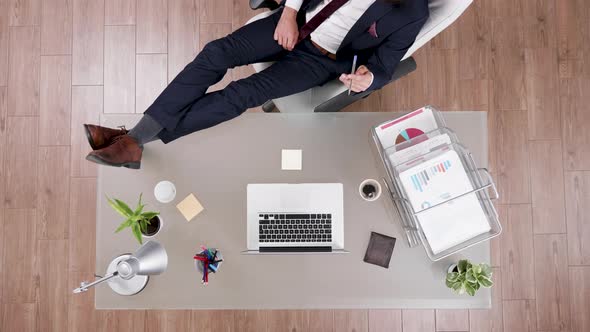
84, 0, 428, 169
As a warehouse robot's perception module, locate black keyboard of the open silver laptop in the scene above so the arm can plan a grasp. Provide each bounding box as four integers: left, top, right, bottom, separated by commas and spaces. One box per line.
258, 213, 332, 243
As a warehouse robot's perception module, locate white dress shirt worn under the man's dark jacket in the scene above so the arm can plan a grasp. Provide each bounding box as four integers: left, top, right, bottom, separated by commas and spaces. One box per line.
285, 0, 376, 54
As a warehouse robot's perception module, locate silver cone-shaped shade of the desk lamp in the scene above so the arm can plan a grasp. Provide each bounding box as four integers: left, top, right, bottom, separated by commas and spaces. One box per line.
117, 241, 168, 280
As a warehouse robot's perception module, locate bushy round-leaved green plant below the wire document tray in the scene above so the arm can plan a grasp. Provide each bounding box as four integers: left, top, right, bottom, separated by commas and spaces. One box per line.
446, 259, 494, 296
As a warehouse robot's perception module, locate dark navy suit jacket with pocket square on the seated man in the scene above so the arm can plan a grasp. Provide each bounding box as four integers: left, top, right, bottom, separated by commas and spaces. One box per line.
284, 0, 428, 90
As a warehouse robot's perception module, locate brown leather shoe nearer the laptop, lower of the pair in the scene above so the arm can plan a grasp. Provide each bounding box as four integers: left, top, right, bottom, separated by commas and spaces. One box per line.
86, 135, 143, 169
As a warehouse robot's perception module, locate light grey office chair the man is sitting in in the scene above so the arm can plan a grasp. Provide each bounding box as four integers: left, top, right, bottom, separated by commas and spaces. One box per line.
246, 0, 473, 113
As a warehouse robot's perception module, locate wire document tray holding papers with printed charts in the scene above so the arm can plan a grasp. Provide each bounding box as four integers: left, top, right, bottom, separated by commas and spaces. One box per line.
371, 106, 502, 261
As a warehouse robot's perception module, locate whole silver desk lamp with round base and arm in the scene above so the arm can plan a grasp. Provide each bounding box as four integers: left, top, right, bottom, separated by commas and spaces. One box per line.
74, 241, 168, 295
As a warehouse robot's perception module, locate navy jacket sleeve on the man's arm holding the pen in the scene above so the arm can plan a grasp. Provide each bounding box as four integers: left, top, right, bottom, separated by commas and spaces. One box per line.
367, 16, 428, 91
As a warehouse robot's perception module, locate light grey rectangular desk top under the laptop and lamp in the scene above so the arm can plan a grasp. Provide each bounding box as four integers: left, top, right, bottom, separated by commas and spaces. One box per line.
97, 112, 490, 309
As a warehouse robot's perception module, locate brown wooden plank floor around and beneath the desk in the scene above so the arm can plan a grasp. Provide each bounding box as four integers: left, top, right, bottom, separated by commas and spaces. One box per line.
0, 0, 590, 332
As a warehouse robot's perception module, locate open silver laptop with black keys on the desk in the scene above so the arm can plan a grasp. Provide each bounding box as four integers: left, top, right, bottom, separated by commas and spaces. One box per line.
244, 183, 347, 254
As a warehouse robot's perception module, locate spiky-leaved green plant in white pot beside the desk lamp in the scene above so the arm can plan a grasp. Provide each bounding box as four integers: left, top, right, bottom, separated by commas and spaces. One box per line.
107, 194, 162, 244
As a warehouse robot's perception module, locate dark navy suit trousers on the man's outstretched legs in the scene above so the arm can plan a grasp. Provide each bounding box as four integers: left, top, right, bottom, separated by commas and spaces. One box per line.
145, 11, 352, 143
